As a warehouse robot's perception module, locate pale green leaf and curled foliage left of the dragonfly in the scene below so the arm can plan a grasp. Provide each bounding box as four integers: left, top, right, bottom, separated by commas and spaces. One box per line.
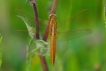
18, 11, 48, 71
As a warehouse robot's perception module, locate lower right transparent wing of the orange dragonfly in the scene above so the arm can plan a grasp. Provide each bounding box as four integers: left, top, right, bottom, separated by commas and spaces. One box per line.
57, 29, 92, 41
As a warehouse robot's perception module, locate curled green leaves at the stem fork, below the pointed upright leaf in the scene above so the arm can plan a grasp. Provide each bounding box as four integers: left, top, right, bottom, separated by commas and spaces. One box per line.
26, 39, 47, 71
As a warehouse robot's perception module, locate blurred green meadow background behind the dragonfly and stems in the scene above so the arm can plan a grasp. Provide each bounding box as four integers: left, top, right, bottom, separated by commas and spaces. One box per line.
0, 0, 106, 71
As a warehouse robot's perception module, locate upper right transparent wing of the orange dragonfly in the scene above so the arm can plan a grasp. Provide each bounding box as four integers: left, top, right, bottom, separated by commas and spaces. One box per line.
57, 9, 90, 31
